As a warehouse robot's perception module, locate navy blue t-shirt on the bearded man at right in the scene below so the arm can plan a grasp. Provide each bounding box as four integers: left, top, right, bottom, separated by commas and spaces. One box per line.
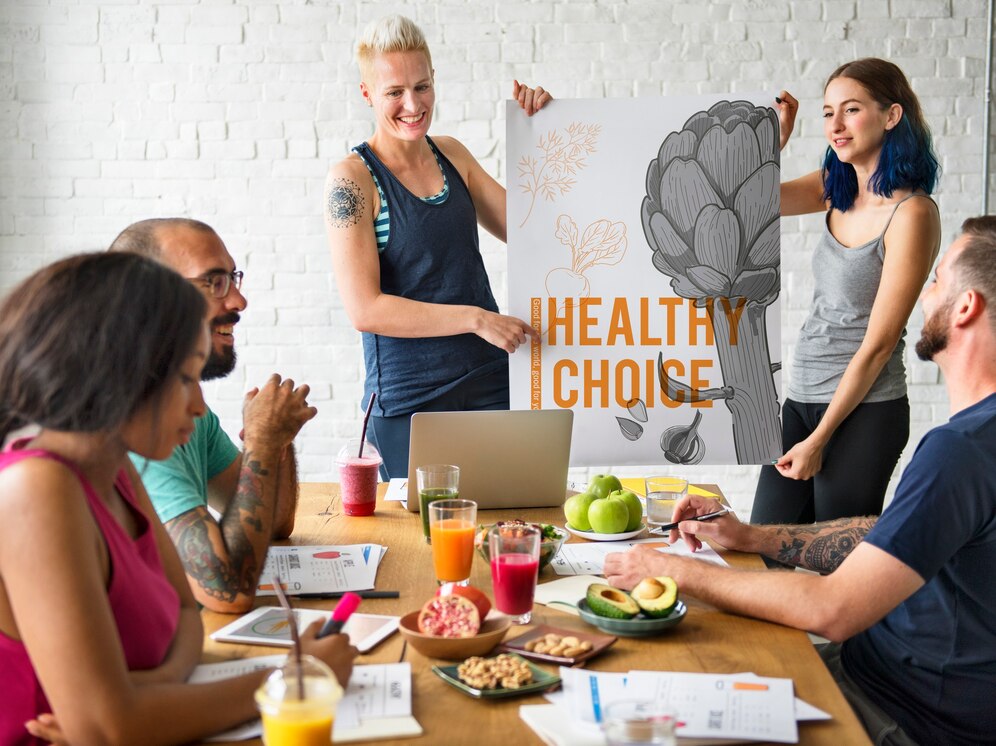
842, 394, 996, 744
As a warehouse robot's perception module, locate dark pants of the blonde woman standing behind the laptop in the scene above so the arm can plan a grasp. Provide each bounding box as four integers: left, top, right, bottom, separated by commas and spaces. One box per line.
367, 368, 509, 480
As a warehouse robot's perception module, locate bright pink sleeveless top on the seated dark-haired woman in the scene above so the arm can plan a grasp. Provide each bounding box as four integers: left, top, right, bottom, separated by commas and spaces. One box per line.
0, 444, 180, 746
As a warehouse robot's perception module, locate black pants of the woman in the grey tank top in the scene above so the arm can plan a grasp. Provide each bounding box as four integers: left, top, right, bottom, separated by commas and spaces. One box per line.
750, 396, 910, 523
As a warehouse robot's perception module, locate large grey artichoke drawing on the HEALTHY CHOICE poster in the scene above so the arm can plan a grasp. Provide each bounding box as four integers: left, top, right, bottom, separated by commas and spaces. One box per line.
641, 101, 781, 464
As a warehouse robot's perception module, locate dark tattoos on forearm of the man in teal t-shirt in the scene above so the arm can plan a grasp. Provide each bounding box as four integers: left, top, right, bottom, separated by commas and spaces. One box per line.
166, 452, 269, 602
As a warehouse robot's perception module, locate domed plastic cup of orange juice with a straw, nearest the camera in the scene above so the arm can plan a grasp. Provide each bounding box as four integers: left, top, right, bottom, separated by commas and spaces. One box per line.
256, 655, 342, 746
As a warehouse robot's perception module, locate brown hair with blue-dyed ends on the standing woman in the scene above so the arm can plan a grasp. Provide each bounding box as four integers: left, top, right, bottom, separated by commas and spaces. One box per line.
822, 57, 940, 212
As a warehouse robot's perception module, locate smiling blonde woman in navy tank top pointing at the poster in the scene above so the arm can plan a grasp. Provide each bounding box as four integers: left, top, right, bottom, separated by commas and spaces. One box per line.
325, 16, 550, 477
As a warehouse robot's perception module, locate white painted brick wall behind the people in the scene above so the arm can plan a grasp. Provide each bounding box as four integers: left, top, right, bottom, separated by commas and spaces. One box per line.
0, 0, 985, 512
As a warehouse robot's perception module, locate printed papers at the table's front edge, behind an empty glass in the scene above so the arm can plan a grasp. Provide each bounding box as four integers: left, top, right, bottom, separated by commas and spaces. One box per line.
519, 668, 830, 746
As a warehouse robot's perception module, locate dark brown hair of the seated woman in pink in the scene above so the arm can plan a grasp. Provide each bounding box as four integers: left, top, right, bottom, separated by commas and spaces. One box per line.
0, 252, 206, 443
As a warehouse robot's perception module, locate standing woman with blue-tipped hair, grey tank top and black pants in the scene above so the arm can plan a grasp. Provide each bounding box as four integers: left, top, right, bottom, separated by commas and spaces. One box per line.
751, 58, 940, 523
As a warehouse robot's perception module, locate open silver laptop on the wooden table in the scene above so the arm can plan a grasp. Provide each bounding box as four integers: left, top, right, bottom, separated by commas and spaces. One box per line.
408, 409, 574, 513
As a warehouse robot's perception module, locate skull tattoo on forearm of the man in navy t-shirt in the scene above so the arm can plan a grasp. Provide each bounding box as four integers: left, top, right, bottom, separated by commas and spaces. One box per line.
775, 518, 876, 575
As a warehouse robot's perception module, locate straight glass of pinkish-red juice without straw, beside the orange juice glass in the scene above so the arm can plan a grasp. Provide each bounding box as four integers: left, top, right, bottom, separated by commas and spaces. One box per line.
488, 525, 543, 624
